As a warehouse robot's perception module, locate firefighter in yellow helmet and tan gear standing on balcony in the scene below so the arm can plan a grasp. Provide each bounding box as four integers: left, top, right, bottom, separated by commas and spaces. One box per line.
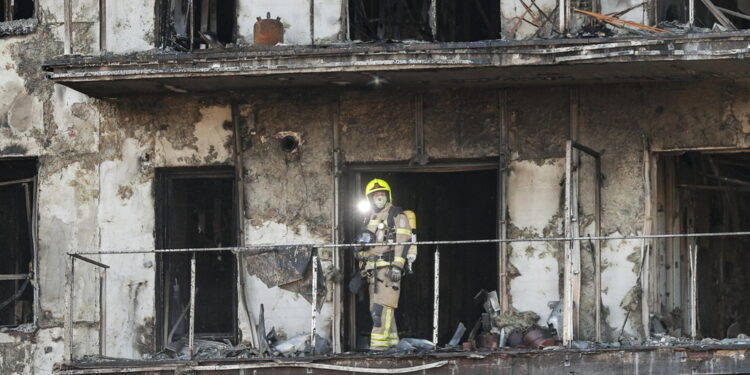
356, 178, 416, 350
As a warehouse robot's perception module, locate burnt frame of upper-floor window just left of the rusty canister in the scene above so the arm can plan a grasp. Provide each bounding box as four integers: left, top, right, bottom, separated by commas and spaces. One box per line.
154, 0, 241, 51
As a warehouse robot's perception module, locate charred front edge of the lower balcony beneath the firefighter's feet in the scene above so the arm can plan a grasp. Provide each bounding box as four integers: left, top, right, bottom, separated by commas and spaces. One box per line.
56, 345, 750, 375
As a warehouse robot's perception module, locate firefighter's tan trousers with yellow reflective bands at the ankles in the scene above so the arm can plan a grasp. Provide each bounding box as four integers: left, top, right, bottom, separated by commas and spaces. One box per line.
368, 267, 401, 350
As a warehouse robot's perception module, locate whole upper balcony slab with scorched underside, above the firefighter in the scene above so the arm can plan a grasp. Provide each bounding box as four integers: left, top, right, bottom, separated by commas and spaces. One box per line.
43, 31, 750, 98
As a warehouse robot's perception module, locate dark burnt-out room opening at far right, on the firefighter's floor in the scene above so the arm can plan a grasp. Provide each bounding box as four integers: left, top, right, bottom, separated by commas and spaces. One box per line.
660, 152, 750, 339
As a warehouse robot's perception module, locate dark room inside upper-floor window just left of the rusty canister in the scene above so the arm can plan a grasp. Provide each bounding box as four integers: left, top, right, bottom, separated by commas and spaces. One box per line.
162, 0, 237, 50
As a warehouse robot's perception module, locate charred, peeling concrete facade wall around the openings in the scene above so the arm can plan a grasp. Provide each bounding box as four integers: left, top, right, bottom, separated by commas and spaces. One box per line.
0, 1, 750, 374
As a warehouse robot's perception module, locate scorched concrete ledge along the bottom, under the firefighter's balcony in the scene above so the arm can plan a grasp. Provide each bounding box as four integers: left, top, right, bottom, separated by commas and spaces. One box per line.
57, 346, 750, 375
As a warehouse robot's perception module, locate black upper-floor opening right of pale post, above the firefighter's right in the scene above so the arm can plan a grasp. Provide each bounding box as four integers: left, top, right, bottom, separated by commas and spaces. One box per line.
436, 0, 500, 42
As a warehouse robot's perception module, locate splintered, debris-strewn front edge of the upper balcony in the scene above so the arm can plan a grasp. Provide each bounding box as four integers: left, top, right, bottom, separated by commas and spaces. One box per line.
43, 32, 750, 82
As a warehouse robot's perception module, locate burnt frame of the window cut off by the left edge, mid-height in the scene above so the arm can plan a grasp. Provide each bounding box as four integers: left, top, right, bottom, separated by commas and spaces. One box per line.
0, 157, 40, 330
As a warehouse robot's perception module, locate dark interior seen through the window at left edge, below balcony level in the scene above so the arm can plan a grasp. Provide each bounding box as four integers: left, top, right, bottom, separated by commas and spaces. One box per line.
0, 159, 37, 326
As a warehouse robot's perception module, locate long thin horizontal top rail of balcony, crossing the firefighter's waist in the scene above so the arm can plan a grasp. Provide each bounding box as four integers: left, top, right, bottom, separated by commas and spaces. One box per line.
67, 231, 750, 256
